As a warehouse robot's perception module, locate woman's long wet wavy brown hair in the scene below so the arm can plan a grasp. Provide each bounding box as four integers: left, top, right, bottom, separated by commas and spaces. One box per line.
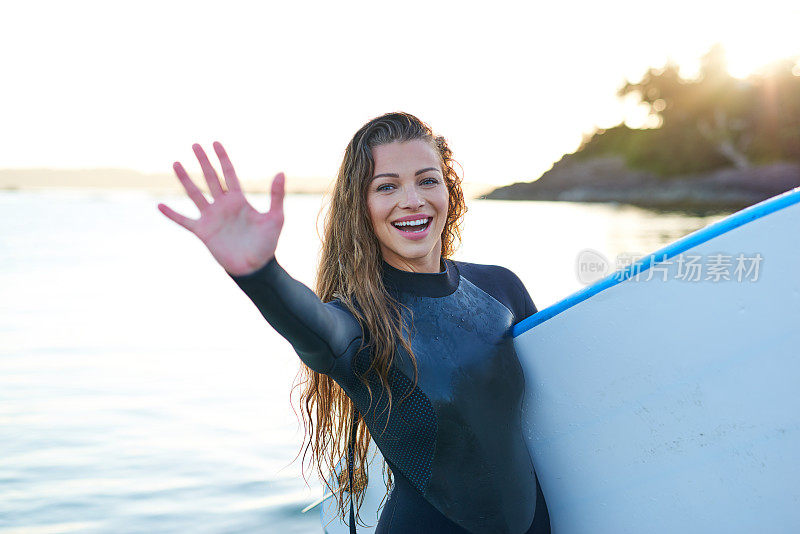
297, 112, 467, 519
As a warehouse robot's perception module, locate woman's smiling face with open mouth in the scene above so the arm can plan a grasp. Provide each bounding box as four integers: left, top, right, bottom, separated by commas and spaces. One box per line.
367, 139, 449, 273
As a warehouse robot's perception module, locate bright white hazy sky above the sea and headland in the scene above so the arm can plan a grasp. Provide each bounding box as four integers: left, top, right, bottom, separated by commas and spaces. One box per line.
0, 0, 800, 184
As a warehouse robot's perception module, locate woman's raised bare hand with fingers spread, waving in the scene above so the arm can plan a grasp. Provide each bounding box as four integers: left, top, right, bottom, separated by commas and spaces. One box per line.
158, 143, 286, 276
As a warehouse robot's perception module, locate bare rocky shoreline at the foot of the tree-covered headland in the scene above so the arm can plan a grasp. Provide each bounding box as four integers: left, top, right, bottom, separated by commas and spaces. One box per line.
482, 156, 800, 211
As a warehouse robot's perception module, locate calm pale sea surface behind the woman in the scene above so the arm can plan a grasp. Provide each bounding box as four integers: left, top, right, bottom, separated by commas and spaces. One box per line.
0, 191, 722, 534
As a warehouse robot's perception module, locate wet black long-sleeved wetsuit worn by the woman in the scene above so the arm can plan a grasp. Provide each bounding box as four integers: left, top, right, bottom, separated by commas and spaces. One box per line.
232, 259, 550, 534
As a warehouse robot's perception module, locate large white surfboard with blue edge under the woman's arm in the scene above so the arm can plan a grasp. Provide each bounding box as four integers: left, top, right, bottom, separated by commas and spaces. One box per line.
320, 188, 800, 534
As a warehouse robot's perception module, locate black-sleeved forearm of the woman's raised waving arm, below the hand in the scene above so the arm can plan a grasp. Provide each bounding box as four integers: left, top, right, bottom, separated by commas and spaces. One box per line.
228, 258, 361, 373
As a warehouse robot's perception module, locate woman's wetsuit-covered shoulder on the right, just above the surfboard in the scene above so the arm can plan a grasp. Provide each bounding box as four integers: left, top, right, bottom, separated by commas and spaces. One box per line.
449, 260, 536, 322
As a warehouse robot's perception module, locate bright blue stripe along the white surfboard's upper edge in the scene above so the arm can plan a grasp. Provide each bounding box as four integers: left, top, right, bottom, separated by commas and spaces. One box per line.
513, 187, 800, 337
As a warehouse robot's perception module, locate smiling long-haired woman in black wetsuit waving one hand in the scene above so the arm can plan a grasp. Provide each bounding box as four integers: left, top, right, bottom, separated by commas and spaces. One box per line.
159, 113, 550, 534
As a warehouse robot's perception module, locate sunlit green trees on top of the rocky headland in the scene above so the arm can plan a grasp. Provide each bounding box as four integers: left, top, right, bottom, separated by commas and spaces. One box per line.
576, 45, 800, 177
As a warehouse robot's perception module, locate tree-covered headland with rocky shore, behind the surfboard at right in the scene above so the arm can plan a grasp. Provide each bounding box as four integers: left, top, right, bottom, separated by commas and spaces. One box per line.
483, 45, 800, 210
